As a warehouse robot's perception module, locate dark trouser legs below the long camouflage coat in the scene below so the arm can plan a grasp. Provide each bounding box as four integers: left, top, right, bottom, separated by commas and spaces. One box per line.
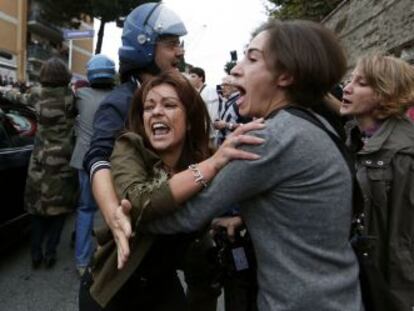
31, 214, 66, 260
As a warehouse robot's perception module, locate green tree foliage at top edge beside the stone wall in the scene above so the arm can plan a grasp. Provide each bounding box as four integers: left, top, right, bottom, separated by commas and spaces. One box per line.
268, 0, 342, 21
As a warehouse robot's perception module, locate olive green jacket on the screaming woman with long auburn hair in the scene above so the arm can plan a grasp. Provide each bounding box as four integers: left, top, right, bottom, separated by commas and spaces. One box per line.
90, 133, 178, 306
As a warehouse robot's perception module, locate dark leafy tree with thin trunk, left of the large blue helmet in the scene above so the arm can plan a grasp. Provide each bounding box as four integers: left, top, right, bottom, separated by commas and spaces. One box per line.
36, 0, 160, 54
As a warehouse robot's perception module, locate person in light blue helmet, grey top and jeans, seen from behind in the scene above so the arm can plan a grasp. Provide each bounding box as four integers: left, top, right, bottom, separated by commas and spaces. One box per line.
70, 54, 115, 276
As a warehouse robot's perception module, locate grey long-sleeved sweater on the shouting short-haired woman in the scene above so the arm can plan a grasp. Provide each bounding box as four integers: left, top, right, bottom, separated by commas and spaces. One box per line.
146, 111, 362, 311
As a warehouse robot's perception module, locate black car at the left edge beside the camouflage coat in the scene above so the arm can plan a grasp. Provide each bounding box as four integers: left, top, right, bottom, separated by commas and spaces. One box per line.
0, 97, 36, 251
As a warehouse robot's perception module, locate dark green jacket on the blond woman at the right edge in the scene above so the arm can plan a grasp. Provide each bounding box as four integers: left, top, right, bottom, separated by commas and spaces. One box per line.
351, 118, 414, 311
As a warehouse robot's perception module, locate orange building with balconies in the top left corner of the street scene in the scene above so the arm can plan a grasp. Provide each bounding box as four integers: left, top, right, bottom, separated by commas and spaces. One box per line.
0, 0, 93, 81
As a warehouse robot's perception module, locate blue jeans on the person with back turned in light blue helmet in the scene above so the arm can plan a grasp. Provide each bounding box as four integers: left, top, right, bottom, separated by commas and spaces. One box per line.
75, 170, 98, 267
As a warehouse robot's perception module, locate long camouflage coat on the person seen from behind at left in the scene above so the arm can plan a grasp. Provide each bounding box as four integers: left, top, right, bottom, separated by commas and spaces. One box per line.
25, 87, 78, 215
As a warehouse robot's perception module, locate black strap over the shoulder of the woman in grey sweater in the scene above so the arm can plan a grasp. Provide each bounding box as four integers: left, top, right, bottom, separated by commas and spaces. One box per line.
283, 106, 364, 217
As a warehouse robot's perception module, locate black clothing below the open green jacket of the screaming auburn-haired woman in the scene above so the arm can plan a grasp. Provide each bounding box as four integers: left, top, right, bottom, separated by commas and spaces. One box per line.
79, 235, 188, 311
